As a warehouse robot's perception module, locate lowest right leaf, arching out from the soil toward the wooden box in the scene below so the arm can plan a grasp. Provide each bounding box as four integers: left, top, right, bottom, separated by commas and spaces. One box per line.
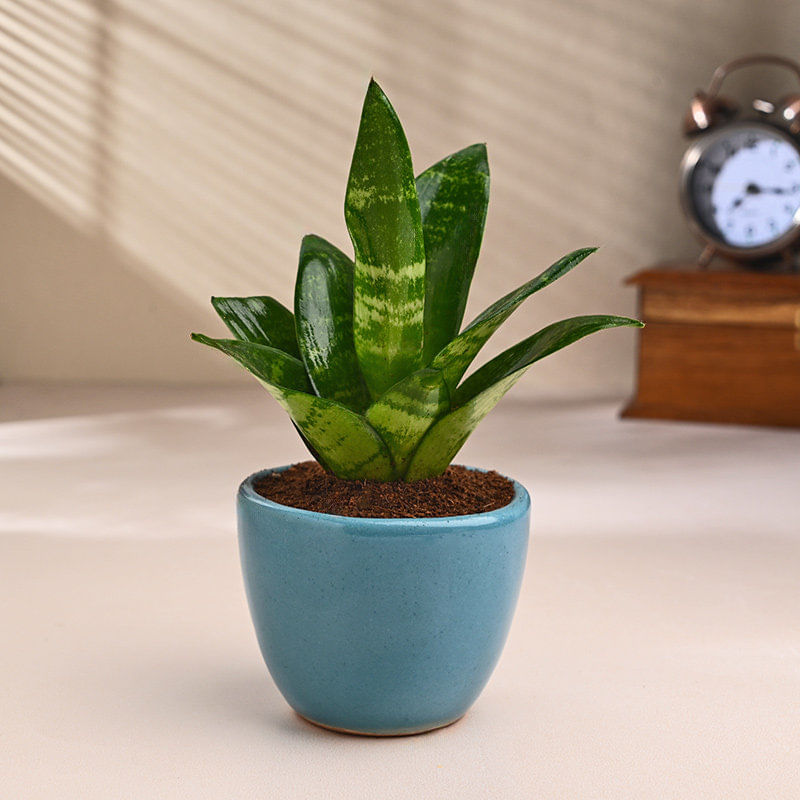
406, 315, 642, 481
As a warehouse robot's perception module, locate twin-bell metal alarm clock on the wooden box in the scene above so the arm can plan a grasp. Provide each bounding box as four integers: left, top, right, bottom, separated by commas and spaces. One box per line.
680, 55, 800, 267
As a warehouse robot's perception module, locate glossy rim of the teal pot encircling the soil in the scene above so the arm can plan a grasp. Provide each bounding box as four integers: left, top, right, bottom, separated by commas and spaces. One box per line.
239, 464, 531, 534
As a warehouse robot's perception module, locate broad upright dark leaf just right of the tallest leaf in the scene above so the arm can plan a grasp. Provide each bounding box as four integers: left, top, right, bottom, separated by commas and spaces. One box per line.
417, 144, 489, 364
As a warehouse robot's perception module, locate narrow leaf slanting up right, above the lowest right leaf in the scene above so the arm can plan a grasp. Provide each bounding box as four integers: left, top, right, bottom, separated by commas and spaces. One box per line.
431, 247, 597, 393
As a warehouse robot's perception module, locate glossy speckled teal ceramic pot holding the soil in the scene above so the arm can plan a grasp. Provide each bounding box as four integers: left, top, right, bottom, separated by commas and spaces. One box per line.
238, 467, 530, 736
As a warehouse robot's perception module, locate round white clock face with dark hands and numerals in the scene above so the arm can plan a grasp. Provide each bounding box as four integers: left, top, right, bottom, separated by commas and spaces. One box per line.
688, 123, 800, 250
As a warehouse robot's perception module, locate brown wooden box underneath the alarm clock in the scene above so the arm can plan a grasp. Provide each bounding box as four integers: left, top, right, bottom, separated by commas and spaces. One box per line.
622, 264, 800, 427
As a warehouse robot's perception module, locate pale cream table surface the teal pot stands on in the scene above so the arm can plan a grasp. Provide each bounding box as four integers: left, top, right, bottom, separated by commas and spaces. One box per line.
0, 385, 800, 800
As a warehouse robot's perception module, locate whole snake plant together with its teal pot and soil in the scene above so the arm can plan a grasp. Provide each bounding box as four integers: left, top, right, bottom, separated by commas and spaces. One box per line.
192, 81, 641, 735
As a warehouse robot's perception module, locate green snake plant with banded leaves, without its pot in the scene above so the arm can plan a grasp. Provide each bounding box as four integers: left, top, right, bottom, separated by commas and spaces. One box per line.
192, 81, 641, 481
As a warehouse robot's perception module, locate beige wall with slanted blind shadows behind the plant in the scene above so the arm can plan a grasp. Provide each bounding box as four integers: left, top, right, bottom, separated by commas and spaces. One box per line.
0, 0, 800, 395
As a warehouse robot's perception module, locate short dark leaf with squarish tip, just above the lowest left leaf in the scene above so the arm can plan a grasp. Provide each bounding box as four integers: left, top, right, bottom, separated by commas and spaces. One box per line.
211, 297, 300, 358
